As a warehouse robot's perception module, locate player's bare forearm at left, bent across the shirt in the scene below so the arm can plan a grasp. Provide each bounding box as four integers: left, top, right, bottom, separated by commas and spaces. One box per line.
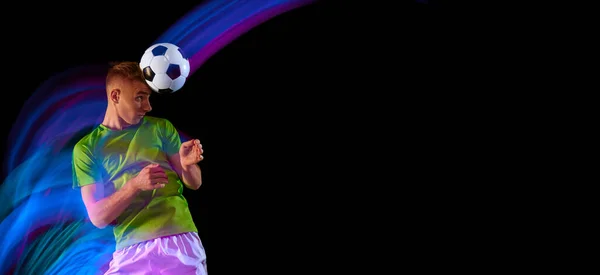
89, 183, 139, 228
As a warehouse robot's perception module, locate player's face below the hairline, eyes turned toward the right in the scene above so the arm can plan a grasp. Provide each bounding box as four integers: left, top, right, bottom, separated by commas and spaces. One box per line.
116, 80, 152, 126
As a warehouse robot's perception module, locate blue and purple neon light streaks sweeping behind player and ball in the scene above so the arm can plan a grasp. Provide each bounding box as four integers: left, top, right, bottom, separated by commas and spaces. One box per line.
0, 0, 316, 274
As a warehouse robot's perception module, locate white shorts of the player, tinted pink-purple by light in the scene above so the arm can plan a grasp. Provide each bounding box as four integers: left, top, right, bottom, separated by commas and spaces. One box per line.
104, 232, 207, 275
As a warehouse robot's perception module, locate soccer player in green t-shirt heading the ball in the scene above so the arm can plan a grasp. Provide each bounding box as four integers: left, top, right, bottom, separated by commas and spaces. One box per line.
73, 61, 207, 274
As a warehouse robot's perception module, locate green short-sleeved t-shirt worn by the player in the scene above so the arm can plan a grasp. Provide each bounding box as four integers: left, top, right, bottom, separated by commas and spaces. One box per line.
73, 116, 198, 250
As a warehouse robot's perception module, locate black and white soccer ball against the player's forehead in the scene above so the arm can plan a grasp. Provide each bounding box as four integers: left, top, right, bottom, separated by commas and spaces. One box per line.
140, 43, 190, 94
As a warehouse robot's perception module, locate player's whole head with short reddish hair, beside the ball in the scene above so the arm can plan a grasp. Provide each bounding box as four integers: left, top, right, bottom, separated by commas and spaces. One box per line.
106, 61, 152, 126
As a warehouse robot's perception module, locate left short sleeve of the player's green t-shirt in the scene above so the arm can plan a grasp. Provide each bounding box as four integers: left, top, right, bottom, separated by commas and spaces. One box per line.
72, 143, 102, 188
